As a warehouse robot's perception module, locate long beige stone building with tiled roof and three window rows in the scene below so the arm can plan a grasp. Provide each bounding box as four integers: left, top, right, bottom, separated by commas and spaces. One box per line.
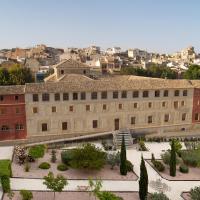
0, 74, 200, 142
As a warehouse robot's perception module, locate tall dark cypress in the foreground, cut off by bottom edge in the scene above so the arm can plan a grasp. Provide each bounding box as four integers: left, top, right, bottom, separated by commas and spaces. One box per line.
139, 156, 148, 200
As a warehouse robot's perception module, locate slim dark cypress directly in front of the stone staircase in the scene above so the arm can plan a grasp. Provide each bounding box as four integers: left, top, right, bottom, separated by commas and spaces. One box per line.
120, 136, 127, 176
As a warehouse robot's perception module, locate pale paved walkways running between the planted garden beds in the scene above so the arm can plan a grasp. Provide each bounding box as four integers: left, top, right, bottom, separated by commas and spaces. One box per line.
0, 143, 200, 200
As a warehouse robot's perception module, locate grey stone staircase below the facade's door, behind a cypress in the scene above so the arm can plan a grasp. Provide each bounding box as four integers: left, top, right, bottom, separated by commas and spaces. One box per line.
113, 130, 133, 149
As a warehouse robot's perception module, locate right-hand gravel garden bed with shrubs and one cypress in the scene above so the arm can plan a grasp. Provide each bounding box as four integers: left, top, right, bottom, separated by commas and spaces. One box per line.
147, 140, 200, 180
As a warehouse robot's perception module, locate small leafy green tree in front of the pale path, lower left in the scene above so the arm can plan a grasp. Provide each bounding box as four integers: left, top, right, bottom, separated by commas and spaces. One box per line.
43, 172, 68, 200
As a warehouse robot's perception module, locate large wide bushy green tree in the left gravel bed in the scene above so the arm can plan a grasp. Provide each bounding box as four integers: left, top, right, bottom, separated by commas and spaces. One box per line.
69, 143, 106, 170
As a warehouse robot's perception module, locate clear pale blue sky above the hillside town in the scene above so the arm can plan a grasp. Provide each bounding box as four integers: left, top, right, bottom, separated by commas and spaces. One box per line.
0, 0, 200, 53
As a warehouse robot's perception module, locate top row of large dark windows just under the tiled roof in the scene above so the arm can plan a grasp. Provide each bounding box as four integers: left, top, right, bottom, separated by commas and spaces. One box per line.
32, 90, 187, 102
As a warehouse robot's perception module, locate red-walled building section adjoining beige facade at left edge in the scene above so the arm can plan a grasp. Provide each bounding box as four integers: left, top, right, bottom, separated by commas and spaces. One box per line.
0, 86, 27, 141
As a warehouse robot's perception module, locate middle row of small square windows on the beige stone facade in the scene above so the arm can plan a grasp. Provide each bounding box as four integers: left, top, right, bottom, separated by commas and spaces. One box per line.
32, 101, 185, 113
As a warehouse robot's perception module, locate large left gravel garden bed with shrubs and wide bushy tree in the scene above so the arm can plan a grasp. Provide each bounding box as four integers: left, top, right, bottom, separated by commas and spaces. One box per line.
12, 143, 137, 180
